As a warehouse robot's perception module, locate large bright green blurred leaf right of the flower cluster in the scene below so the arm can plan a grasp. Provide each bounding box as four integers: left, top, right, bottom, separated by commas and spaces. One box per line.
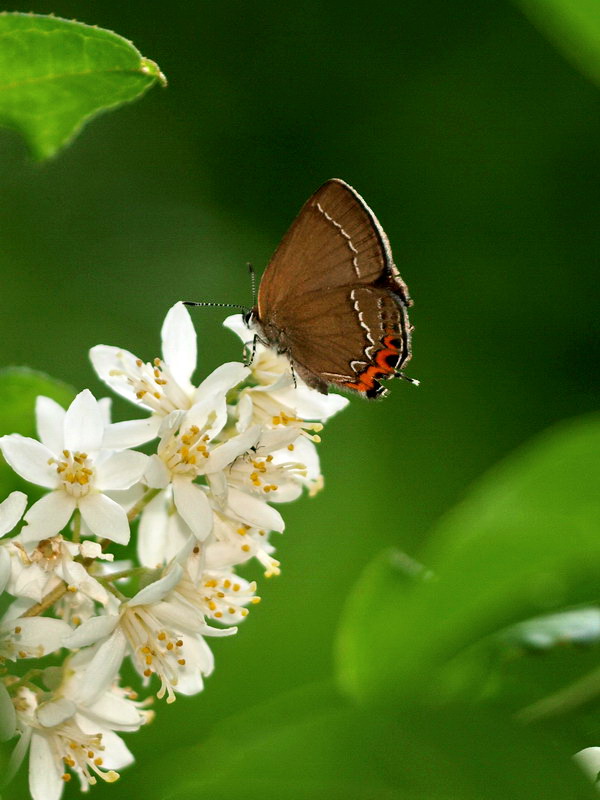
337, 417, 600, 702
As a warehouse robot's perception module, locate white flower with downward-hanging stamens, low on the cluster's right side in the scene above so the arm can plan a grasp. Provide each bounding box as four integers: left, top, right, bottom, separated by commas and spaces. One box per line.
65, 563, 230, 703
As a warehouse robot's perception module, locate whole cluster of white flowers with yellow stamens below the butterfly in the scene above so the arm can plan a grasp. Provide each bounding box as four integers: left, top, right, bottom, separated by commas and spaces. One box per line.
0, 303, 347, 800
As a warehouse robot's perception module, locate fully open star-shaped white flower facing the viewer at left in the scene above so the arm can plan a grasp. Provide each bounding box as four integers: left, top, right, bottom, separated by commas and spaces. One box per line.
0, 389, 148, 544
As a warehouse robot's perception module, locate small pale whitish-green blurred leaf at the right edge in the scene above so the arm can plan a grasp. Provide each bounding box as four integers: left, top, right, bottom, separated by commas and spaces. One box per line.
498, 608, 600, 650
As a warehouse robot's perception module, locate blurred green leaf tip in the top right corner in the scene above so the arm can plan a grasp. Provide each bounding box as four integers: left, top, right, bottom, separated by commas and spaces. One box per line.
516, 0, 600, 83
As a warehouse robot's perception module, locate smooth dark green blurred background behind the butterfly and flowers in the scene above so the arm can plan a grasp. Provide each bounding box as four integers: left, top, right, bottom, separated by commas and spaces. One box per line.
0, 0, 600, 798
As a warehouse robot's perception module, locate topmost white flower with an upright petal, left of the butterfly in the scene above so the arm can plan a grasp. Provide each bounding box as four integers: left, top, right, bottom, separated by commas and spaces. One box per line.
90, 303, 249, 447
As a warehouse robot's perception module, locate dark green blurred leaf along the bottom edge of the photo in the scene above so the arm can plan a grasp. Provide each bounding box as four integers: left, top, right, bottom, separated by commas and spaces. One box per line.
141, 688, 595, 800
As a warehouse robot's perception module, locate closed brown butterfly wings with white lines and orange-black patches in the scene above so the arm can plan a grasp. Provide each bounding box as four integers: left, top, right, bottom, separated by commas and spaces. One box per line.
256, 179, 410, 397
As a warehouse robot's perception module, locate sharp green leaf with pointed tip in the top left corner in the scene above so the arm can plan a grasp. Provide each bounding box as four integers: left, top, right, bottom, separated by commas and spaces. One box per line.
0, 12, 165, 160
